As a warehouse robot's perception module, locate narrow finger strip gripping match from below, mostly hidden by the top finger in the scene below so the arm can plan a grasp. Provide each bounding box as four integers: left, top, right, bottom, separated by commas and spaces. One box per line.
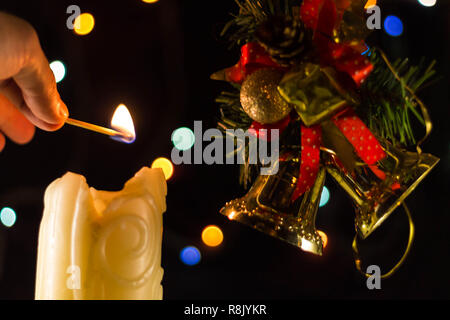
0, 78, 64, 131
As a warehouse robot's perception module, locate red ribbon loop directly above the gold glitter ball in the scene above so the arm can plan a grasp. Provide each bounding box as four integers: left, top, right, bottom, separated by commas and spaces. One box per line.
225, 42, 285, 83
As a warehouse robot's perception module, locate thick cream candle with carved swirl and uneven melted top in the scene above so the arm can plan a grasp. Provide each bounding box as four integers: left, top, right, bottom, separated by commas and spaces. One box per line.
35, 167, 167, 300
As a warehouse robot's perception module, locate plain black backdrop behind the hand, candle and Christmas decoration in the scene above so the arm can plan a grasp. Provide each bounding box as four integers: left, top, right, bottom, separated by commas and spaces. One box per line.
0, 0, 450, 299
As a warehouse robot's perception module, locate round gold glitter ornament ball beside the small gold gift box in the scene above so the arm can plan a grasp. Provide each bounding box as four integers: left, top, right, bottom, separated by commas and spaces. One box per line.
241, 68, 292, 124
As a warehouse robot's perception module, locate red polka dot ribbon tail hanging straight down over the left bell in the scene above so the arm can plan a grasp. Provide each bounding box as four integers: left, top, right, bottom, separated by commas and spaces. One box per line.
292, 125, 322, 201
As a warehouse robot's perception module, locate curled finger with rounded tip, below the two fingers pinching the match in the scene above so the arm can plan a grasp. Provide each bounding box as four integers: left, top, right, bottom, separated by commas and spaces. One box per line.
0, 94, 35, 144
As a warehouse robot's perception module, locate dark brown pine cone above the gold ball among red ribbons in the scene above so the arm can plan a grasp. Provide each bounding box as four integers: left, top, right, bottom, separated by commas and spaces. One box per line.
255, 16, 312, 65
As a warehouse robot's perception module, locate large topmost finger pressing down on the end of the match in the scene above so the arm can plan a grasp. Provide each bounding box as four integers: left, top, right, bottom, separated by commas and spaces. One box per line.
0, 13, 68, 130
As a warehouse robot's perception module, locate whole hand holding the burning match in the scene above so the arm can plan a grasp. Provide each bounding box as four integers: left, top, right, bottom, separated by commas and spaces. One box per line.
0, 12, 68, 151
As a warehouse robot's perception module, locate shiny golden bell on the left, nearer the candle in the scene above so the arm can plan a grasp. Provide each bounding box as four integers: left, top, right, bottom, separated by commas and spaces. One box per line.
220, 152, 326, 255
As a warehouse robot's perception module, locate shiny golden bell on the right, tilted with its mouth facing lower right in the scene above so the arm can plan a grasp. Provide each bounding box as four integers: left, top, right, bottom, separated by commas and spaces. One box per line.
325, 141, 439, 239
